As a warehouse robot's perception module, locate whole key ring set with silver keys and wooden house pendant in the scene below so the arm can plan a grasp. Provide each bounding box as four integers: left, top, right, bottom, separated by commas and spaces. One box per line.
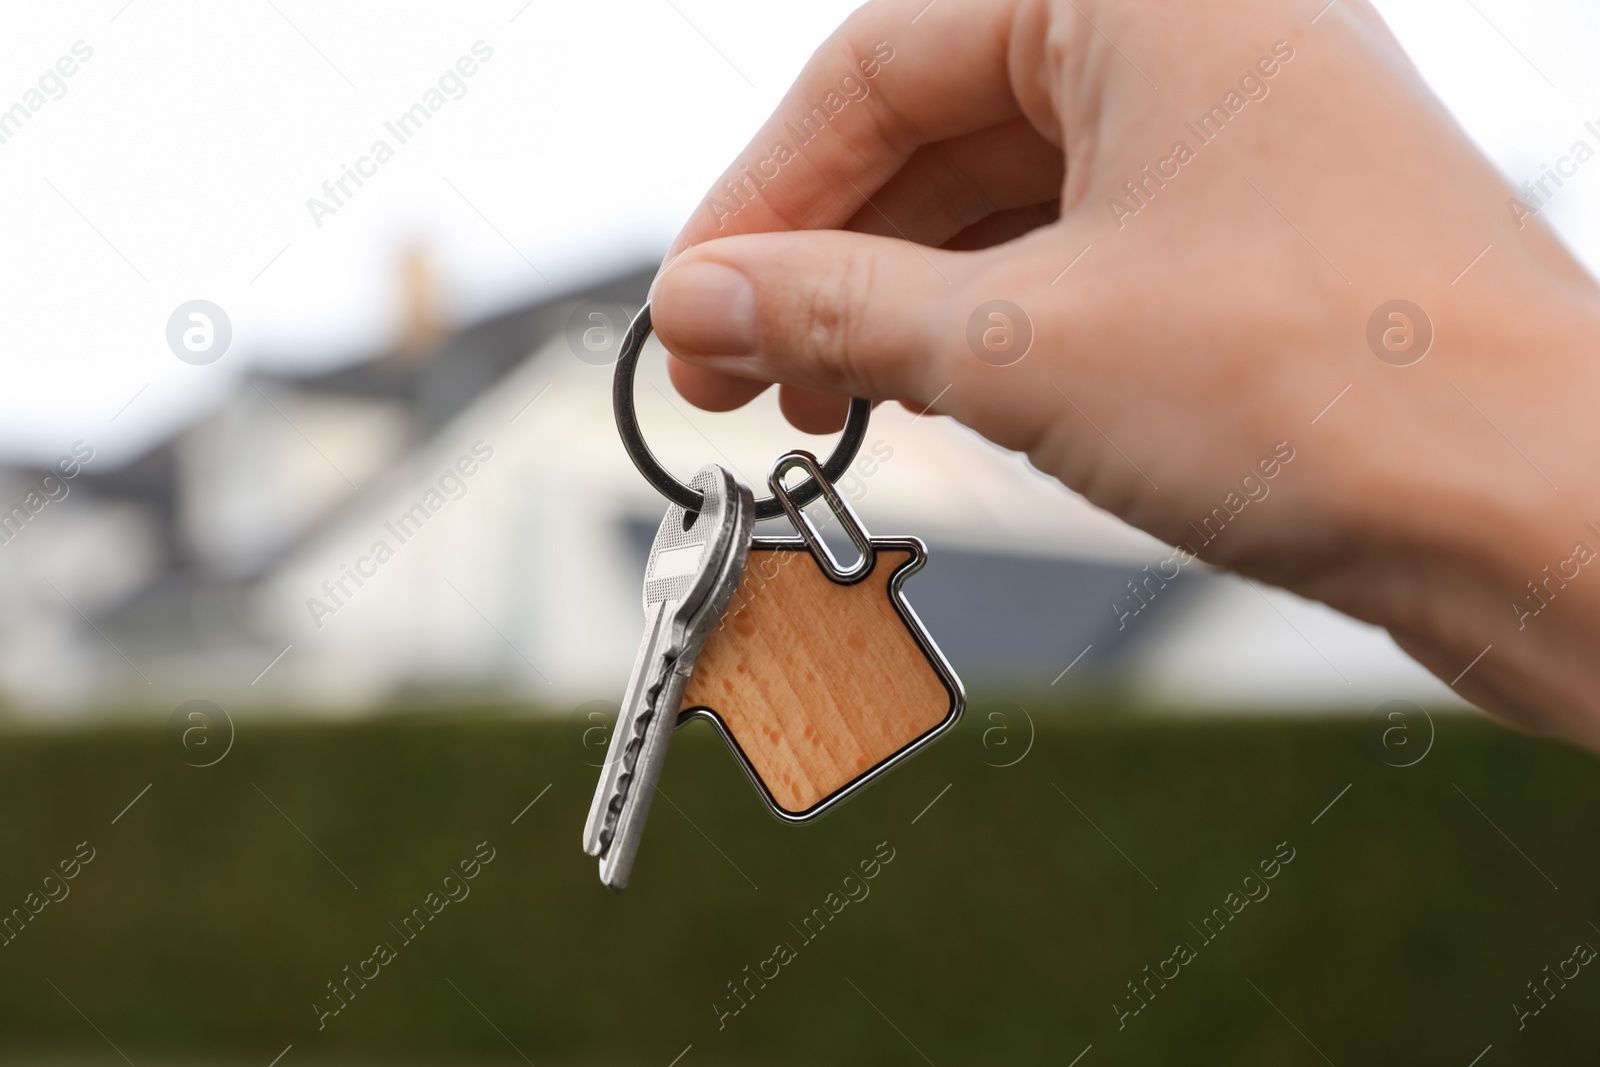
584, 304, 966, 891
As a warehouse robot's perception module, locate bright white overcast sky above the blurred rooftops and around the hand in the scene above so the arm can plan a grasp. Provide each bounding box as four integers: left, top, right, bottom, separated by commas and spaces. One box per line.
0, 0, 1600, 458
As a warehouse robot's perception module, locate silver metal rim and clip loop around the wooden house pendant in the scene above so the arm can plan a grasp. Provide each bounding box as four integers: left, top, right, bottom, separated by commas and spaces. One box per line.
677, 450, 966, 824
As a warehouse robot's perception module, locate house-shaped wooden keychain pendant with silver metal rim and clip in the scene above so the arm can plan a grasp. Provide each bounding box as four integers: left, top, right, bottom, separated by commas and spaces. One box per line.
678, 451, 966, 822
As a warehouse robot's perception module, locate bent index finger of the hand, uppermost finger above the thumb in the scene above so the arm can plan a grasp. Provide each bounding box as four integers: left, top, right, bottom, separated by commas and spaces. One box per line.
667, 0, 1043, 262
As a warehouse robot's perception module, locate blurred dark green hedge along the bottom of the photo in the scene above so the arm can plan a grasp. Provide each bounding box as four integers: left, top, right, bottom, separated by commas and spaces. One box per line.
0, 702, 1600, 1067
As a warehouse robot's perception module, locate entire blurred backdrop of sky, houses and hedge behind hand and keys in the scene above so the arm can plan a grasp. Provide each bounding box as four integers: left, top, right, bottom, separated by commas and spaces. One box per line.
0, 0, 1600, 1067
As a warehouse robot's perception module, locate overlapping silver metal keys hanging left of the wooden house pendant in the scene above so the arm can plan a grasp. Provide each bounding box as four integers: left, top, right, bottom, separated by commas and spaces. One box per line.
584, 464, 755, 891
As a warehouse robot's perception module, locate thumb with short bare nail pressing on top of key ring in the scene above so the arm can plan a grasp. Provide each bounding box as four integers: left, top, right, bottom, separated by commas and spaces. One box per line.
651, 230, 971, 400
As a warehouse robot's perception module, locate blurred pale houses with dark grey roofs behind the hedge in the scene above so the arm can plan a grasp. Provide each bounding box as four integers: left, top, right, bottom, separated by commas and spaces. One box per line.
0, 262, 1451, 713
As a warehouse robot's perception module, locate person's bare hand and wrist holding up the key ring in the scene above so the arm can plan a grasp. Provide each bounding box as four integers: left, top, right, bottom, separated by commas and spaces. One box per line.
653, 0, 1600, 749
